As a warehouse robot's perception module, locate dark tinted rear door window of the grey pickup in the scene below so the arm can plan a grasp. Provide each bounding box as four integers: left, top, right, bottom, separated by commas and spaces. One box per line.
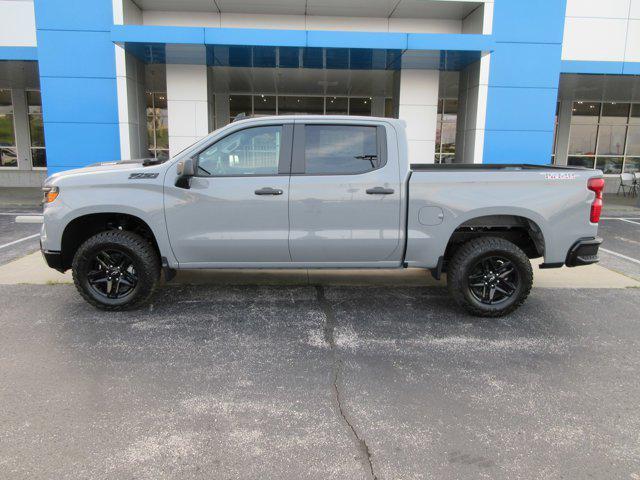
304, 125, 381, 175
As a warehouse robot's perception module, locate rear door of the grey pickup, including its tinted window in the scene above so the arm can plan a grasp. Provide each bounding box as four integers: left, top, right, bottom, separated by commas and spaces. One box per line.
289, 121, 402, 266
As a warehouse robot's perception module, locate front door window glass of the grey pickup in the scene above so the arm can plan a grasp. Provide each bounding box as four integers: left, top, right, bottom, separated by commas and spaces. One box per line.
198, 126, 282, 176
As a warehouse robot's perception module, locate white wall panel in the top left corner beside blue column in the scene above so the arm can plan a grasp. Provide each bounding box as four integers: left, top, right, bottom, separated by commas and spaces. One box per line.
0, 0, 37, 47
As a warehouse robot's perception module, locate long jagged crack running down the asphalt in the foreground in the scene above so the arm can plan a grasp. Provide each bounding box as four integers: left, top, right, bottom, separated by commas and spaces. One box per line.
316, 285, 378, 480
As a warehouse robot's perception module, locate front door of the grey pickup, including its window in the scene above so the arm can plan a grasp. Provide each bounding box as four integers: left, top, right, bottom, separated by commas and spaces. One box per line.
165, 122, 293, 268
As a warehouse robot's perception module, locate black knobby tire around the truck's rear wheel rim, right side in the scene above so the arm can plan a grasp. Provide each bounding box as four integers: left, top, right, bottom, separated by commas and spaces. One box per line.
447, 237, 533, 317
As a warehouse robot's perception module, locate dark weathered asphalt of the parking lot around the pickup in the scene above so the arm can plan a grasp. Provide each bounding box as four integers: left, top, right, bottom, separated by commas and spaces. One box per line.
0, 198, 640, 480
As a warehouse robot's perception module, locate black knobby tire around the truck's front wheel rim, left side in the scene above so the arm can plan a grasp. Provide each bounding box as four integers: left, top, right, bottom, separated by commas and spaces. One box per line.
71, 230, 160, 311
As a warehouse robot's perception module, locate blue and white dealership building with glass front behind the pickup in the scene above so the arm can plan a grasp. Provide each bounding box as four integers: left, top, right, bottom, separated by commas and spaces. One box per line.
0, 0, 640, 190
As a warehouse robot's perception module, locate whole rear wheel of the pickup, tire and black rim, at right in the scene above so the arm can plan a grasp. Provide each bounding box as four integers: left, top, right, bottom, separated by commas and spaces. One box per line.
447, 237, 533, 317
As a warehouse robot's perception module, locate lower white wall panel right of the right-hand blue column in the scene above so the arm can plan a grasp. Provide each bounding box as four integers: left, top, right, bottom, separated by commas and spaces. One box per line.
562, 18, 627, 62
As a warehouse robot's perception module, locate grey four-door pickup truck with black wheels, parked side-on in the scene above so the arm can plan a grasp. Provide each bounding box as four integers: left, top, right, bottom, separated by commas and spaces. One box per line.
40, 116, 604, 317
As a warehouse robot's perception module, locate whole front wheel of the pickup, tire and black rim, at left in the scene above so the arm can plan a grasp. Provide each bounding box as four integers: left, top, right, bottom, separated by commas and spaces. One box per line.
72, 230, 160, 310
